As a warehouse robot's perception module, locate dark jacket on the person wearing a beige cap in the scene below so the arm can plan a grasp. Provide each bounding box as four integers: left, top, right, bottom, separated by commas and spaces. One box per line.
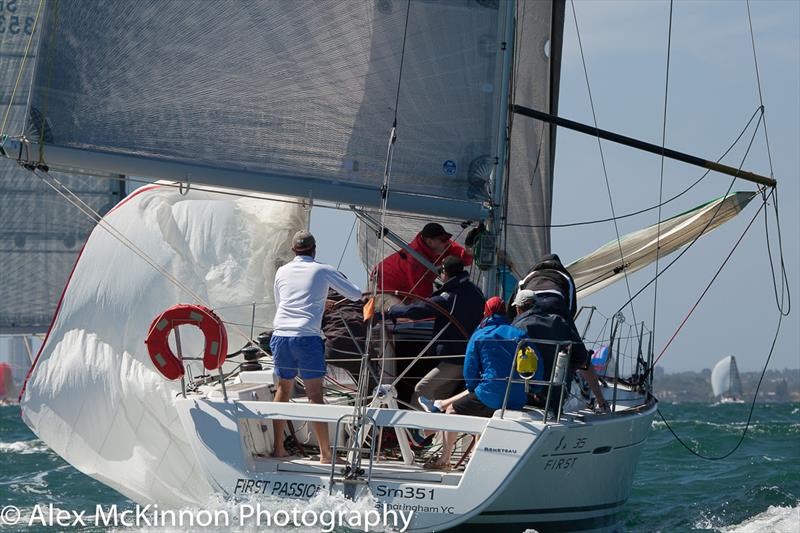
511, 294, 589, 380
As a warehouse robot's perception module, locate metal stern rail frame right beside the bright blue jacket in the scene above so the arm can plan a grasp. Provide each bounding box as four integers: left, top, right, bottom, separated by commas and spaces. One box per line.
500, 339, 579, 423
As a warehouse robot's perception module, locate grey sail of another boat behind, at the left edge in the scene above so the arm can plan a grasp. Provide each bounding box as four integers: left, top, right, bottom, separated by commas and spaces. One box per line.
0, 0, 125, 334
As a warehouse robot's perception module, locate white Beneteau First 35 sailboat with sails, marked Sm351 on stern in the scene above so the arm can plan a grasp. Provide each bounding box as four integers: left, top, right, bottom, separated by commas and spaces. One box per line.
3, 0, 776, 531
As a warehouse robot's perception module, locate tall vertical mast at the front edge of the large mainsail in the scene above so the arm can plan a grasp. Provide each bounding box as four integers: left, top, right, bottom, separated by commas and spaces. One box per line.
481, 0, 516, 297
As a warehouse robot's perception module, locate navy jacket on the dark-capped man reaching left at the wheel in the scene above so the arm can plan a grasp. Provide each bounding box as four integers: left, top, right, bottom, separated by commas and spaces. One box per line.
385, 272, 486, 356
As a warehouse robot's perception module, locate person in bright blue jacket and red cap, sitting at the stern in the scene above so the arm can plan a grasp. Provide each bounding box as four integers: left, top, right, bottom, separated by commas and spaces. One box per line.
425, 296, 544, 470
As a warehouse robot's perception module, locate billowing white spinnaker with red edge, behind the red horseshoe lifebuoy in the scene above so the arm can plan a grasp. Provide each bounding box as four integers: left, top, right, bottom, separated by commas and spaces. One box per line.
21, 186, 305, 506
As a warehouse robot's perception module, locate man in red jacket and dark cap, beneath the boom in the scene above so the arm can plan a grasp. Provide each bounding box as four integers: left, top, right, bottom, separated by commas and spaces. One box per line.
373, 222, 472, 298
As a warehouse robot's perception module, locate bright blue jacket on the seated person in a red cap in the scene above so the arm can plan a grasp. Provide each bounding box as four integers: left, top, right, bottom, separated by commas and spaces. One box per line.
464, 315, 544, 409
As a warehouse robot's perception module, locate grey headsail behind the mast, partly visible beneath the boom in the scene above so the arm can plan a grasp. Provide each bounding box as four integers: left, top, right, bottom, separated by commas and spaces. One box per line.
358, 0, 564, 282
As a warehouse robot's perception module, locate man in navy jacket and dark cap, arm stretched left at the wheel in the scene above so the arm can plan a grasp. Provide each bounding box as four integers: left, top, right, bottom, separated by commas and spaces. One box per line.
384, 257, 485, 406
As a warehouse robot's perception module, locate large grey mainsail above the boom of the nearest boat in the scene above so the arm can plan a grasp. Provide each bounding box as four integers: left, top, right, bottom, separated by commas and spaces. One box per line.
14, 0, 508, 217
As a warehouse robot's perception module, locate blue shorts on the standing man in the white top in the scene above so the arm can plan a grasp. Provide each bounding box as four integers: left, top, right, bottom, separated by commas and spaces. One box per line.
269, 335, 326, 379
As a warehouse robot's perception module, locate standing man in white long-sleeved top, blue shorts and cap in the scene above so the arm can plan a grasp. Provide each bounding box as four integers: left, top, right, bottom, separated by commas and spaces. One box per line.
269, 231, 361, 464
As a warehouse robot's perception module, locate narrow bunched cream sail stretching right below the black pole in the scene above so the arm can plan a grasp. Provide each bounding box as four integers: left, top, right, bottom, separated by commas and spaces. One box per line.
567, 192, 755, 298
